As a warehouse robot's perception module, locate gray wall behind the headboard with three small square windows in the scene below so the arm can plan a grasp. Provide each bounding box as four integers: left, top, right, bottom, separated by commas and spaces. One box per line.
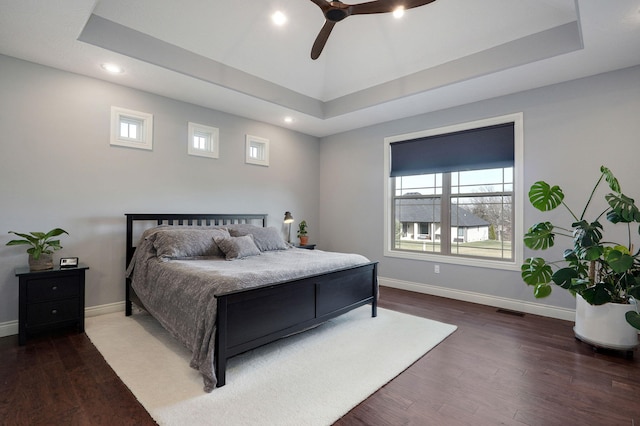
0, 56, 320, 326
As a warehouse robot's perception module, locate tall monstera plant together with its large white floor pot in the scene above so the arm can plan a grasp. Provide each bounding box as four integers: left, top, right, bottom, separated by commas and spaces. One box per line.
521, 166, 640, 351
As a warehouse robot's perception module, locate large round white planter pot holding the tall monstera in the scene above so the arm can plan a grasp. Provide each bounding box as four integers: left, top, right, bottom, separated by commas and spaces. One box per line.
573, 295, 638, 350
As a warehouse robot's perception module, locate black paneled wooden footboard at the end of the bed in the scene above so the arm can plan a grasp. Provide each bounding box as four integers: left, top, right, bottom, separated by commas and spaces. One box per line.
215, 262, 378, 387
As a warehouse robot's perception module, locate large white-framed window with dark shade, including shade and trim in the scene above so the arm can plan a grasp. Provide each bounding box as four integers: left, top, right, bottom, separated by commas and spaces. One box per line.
385, 114, 522, 269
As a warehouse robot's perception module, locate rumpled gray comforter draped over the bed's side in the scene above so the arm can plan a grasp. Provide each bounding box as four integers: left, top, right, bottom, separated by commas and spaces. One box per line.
127, 233, 369, 392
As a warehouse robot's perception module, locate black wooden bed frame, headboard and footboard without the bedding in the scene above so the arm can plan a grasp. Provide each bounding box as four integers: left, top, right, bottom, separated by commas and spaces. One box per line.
125, 213, 378, 387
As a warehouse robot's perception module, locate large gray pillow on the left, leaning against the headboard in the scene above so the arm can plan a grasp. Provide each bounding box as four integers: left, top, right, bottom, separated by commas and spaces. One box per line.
151, 226, 229, 259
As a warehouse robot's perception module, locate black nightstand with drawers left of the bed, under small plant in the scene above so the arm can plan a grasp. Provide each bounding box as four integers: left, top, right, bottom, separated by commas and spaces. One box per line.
15, 264, 89, 345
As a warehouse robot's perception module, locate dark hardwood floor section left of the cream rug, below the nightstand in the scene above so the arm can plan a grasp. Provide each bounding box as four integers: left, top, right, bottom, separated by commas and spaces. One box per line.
0, 328, 156, 425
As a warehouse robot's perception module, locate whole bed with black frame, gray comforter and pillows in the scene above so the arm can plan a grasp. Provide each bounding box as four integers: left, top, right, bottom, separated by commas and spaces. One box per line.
125, 213, 378, 392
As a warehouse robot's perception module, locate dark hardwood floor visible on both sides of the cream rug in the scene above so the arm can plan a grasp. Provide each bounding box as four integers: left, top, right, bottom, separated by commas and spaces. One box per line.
0, 288, 640, 426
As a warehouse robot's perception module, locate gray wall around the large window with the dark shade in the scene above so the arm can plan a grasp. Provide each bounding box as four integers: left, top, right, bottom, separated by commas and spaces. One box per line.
319, 67, 640, 308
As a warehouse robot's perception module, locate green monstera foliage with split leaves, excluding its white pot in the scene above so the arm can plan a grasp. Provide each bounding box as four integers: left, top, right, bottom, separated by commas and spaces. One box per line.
521, 166, 640, 330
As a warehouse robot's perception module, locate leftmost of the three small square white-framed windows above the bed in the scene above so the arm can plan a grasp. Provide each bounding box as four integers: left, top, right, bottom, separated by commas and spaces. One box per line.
111, 107, 153, 150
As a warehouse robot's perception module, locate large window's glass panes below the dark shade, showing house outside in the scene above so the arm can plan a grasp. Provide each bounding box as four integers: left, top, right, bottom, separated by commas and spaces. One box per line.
392, 167, 513, 260
